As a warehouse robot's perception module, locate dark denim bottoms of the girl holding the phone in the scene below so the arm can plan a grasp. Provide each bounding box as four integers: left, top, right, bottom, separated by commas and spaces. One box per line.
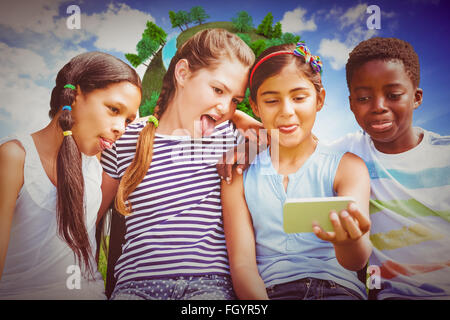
267, 278, 364, 300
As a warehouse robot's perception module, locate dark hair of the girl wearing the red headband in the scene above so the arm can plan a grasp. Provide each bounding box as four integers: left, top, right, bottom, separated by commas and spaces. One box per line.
248, 44, 323, 102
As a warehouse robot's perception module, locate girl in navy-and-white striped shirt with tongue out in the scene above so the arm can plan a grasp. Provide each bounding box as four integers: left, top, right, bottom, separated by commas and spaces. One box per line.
102, 29, 259, 299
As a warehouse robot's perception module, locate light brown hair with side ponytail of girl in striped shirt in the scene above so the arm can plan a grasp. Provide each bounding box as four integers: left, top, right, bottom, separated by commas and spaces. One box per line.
115, 29, 255, 215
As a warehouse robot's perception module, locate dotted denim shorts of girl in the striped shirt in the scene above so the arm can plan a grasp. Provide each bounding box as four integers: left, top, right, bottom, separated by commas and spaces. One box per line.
110, 275, 236, 300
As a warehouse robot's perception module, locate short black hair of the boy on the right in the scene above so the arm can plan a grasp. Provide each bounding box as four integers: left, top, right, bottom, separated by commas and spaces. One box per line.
345, 37, 420, 90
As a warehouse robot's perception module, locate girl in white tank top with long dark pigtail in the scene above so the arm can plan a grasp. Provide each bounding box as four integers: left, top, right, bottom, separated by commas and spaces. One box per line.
0, 52, 141, 299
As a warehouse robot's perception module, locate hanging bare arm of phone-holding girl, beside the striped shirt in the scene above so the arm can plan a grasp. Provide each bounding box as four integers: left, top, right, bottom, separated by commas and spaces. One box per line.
221, 170, 268, 300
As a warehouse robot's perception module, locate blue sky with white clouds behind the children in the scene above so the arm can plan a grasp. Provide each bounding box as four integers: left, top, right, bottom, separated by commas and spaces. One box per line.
0, 0, 450, 140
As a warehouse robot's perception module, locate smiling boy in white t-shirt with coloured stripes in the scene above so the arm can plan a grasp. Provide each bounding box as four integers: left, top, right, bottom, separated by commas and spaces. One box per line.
333, 38, 450, 299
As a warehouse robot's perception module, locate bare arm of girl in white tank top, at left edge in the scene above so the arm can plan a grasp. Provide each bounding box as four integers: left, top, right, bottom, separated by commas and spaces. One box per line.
0, 141, 25, 279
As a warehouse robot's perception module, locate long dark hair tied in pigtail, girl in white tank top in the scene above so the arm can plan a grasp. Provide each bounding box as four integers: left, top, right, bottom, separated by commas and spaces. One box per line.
49, 52, 141, 275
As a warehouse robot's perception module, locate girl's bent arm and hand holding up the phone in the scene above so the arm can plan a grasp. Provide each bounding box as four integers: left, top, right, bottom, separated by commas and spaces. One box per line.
315, 153, 372, 271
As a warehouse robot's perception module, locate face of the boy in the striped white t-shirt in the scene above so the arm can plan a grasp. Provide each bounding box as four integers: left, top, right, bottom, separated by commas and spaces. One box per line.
349, 60, 422, 153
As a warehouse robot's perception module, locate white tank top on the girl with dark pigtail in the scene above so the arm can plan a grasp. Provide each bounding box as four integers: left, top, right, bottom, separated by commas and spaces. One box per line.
0, 135, 106, 299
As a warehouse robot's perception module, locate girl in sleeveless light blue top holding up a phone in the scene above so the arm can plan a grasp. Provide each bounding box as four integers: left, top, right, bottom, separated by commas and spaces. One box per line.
222, 42, 371, 299
